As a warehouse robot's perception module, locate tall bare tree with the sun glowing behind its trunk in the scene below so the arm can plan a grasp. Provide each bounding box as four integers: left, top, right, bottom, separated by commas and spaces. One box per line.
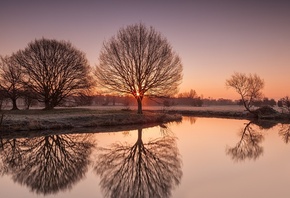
95, 24, 182, 114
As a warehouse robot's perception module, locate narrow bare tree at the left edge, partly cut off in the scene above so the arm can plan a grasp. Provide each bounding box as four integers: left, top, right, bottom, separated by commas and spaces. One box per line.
0, 56, 23, 110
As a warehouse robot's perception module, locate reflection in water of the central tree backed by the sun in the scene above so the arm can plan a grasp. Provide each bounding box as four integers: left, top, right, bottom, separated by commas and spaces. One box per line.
94, 127, 182, 198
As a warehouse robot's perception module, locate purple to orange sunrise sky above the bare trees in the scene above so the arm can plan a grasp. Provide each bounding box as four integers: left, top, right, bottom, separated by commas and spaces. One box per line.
0, 0, 290, 100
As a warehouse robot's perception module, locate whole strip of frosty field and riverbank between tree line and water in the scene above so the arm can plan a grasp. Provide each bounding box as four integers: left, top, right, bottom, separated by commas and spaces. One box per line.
0, 106, 289, 133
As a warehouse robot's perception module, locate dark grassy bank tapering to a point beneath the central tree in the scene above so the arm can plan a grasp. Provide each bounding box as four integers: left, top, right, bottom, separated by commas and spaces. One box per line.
0, 108, 182, 132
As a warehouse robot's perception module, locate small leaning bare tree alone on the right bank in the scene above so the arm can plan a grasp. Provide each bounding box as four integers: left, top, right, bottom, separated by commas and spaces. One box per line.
226, 72, 265, 114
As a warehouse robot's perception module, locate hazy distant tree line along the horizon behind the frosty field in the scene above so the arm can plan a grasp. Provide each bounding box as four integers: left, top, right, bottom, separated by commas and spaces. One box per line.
52, 90, 278, 109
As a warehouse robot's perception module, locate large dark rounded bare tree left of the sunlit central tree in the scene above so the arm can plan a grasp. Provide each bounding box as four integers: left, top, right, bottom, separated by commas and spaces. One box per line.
13, 38, 91, 109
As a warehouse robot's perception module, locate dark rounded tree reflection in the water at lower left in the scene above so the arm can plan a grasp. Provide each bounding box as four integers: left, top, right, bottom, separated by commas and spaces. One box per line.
1, 134, 94, 195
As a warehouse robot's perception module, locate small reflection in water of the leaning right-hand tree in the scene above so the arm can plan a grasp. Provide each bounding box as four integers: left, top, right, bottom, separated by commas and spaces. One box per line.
226, 122, 264, 162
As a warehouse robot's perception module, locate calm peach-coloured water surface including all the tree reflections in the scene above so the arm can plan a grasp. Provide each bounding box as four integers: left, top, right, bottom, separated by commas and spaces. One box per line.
0, 117, 290, 198
